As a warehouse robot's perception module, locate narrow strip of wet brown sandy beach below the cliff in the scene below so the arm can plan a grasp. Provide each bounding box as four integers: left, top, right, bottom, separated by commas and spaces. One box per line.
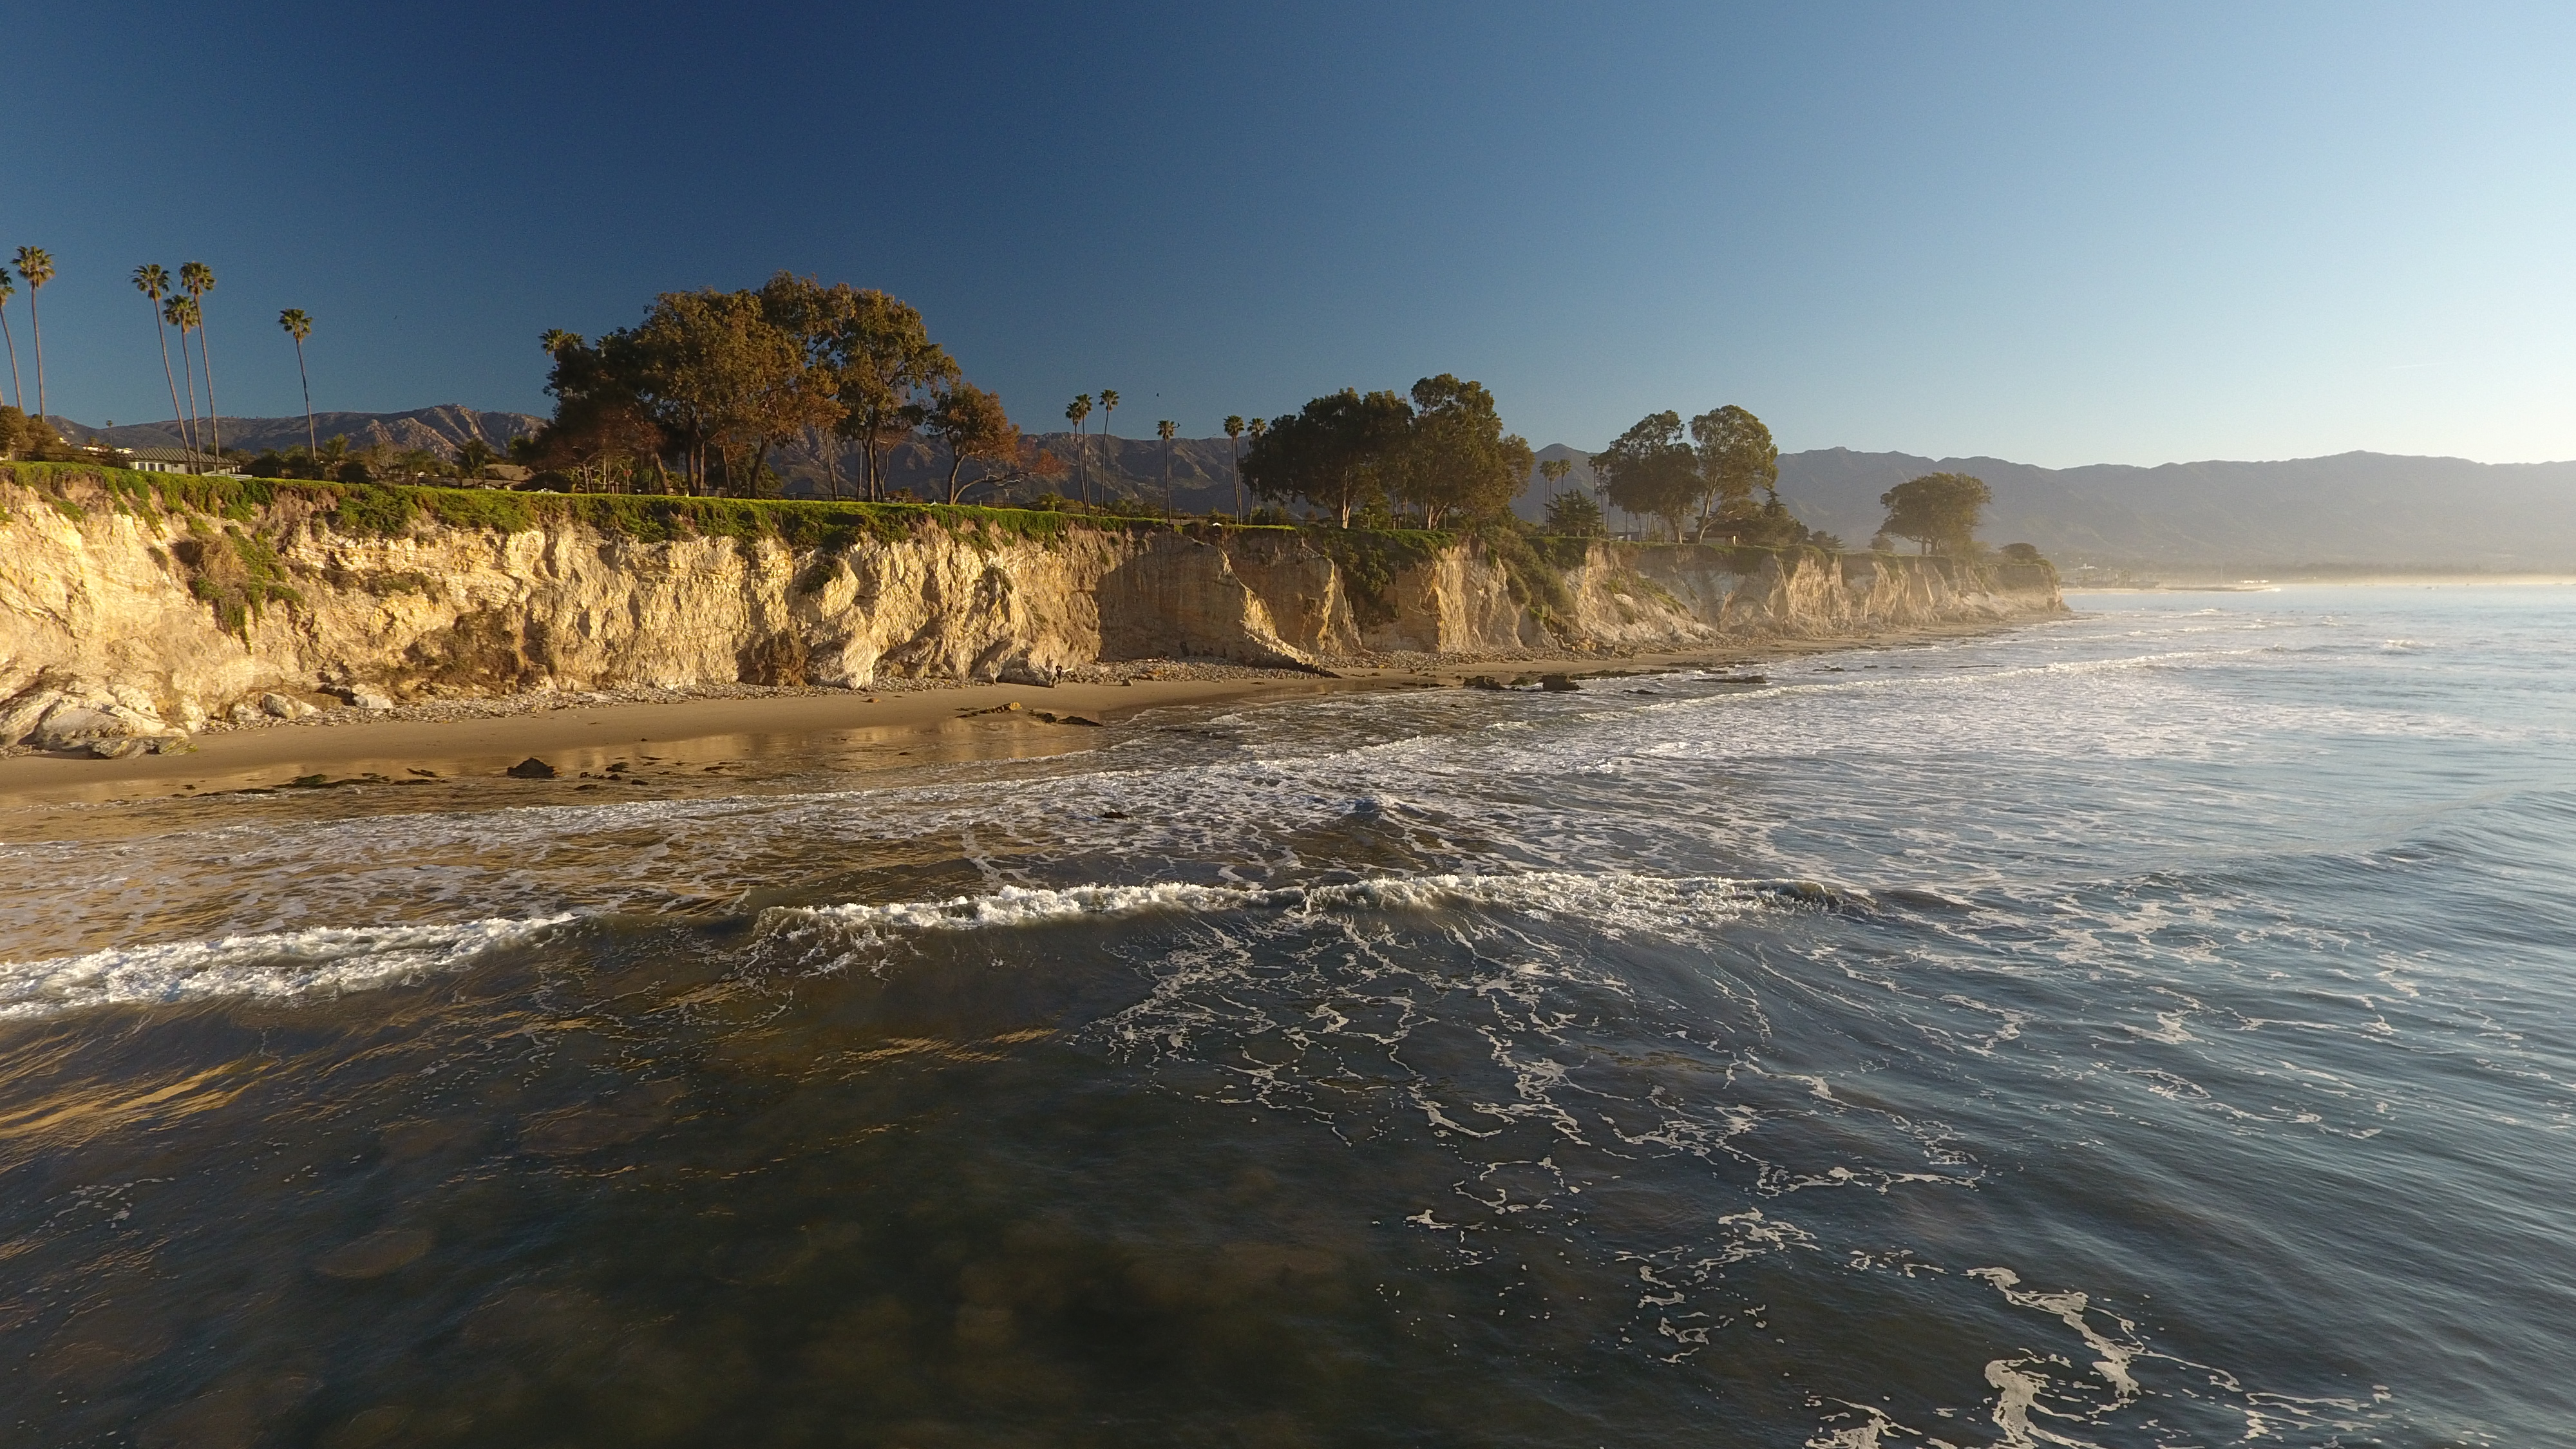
0, 616, 2045, 804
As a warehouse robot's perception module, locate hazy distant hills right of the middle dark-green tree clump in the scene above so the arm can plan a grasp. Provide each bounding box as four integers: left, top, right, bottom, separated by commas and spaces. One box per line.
1520, 444, 2576, 573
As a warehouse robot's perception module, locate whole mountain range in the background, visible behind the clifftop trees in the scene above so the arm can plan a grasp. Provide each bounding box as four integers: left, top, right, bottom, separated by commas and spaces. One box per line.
57, 405, 2576, 573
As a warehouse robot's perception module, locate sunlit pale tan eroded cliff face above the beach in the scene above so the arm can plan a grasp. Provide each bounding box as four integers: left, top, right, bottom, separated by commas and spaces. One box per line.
0, 477, 2061, 748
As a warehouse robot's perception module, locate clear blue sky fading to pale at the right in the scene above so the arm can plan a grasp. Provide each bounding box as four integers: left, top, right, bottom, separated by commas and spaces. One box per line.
0, 0, 2576, 464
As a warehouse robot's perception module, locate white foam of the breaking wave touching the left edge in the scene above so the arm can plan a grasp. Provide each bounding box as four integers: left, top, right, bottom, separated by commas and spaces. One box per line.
0, 915, 572, 1018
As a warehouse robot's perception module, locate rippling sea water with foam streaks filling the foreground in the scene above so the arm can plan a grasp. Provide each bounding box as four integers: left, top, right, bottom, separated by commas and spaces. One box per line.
0, 588, 2576, 1449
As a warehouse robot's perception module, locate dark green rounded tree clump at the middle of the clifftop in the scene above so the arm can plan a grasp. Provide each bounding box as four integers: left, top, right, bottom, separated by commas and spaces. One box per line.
1226, 374, 1533, 529
